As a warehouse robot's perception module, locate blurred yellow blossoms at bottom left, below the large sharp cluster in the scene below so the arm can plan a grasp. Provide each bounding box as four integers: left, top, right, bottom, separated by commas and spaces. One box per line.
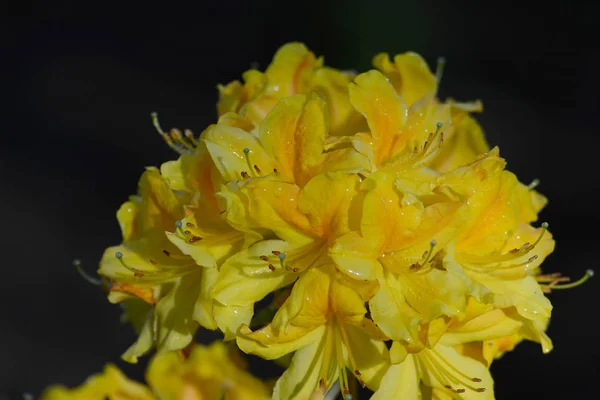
42, 343, 269, 400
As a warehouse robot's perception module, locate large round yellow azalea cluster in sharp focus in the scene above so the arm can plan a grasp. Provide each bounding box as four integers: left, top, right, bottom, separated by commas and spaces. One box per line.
50, 43, 588, 400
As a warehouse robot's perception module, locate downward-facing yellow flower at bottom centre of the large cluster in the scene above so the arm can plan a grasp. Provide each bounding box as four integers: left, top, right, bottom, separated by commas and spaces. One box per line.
237, 264, 389, 400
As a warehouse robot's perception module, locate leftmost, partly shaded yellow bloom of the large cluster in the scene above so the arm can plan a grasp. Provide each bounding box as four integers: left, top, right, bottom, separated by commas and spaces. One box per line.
99, 141, 260, 362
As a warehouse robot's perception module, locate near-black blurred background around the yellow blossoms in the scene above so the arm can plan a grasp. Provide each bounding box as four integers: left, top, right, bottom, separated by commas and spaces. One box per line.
0, 0, 600, 399
